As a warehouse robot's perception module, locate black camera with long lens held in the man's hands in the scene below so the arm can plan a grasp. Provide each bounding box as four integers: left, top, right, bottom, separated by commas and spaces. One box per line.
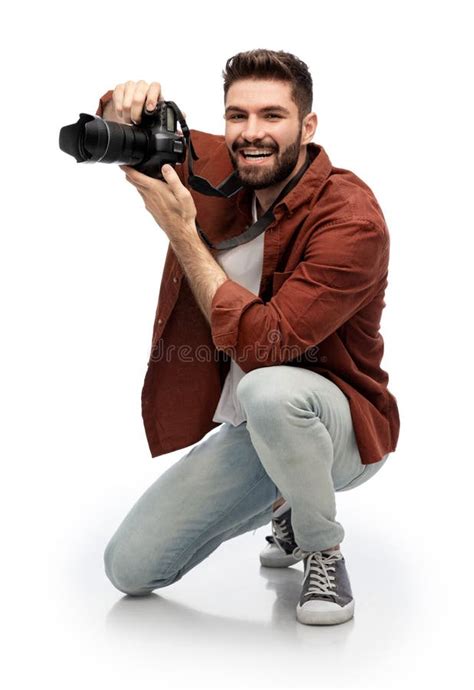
59, 101, 186, 180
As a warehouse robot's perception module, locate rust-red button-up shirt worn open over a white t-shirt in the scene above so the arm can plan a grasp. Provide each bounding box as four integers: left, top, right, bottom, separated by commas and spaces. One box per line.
96, 91, 400, 464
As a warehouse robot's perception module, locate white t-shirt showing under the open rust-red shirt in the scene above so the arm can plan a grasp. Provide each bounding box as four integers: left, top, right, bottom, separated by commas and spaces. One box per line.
213, 189, 265, 426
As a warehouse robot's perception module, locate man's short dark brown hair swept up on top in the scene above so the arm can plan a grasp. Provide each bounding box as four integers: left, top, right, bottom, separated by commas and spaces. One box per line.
222, 48, 313, 120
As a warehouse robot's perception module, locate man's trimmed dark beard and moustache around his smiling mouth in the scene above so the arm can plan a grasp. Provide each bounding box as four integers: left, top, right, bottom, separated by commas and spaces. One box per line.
229, 126, 302, 189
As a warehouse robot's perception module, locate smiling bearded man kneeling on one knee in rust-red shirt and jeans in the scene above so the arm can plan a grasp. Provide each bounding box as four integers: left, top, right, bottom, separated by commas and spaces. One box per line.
98, 50, 399, 625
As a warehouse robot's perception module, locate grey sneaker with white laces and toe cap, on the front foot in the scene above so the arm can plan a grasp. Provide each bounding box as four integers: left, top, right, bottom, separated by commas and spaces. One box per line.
295, 547, 354, 625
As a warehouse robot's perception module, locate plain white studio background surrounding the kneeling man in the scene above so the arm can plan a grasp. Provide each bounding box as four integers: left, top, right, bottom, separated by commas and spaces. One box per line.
0, 0, 473, 690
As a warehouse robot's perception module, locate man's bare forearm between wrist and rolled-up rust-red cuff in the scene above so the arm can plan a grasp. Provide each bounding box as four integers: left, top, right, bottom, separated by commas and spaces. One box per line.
170, 226, 228, 324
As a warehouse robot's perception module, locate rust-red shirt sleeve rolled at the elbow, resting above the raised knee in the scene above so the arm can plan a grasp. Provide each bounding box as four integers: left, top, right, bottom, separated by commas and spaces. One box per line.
211, 218, 389, 373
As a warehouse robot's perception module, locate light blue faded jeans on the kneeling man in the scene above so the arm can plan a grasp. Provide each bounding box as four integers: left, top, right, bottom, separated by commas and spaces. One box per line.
104, 365, 388, 596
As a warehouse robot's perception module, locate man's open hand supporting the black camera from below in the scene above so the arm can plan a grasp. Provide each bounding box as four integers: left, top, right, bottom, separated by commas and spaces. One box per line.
119, 165, 197, 244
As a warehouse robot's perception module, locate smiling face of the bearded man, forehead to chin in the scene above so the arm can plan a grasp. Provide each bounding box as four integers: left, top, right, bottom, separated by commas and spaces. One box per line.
224, 79, 304, 189
